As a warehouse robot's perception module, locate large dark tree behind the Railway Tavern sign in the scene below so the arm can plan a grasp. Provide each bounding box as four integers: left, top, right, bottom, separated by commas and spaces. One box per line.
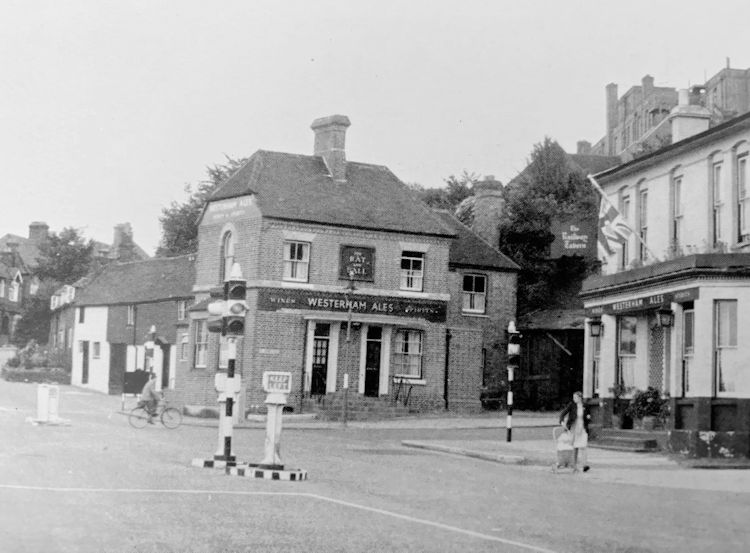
500, 138, 598, 314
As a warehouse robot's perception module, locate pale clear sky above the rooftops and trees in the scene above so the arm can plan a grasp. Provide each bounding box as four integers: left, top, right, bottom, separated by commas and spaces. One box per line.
0, 0, 750, 253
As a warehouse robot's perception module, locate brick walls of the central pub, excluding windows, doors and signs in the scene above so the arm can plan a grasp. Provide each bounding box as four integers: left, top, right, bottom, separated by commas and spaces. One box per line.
178, 198, 516, 411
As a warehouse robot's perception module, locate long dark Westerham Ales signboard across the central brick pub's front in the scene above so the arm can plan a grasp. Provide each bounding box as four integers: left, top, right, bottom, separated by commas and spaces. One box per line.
258, 288, 448, 323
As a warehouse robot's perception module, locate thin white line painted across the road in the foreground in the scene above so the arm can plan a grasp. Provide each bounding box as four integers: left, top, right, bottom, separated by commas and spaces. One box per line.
0, 484, 557, 553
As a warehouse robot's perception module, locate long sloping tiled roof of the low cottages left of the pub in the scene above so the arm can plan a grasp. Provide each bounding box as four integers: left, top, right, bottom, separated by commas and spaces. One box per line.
75, 255, 195, 305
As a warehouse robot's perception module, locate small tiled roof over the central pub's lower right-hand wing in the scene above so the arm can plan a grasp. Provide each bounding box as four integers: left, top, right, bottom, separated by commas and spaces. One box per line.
434, 209, 520, 271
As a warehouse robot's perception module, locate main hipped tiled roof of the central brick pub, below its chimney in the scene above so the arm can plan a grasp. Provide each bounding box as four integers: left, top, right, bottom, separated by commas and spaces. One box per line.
211, 150, 453, 236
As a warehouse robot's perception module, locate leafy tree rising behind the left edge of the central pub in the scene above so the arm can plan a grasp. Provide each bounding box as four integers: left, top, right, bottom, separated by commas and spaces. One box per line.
156, 155, 247, 257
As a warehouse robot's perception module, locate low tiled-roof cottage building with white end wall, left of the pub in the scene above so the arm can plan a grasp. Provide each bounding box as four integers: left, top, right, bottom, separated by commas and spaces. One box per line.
49, 256, 195, 393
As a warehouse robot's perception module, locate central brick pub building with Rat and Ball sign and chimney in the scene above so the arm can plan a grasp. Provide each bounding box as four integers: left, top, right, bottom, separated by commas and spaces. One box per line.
177, 115, 517, 412
